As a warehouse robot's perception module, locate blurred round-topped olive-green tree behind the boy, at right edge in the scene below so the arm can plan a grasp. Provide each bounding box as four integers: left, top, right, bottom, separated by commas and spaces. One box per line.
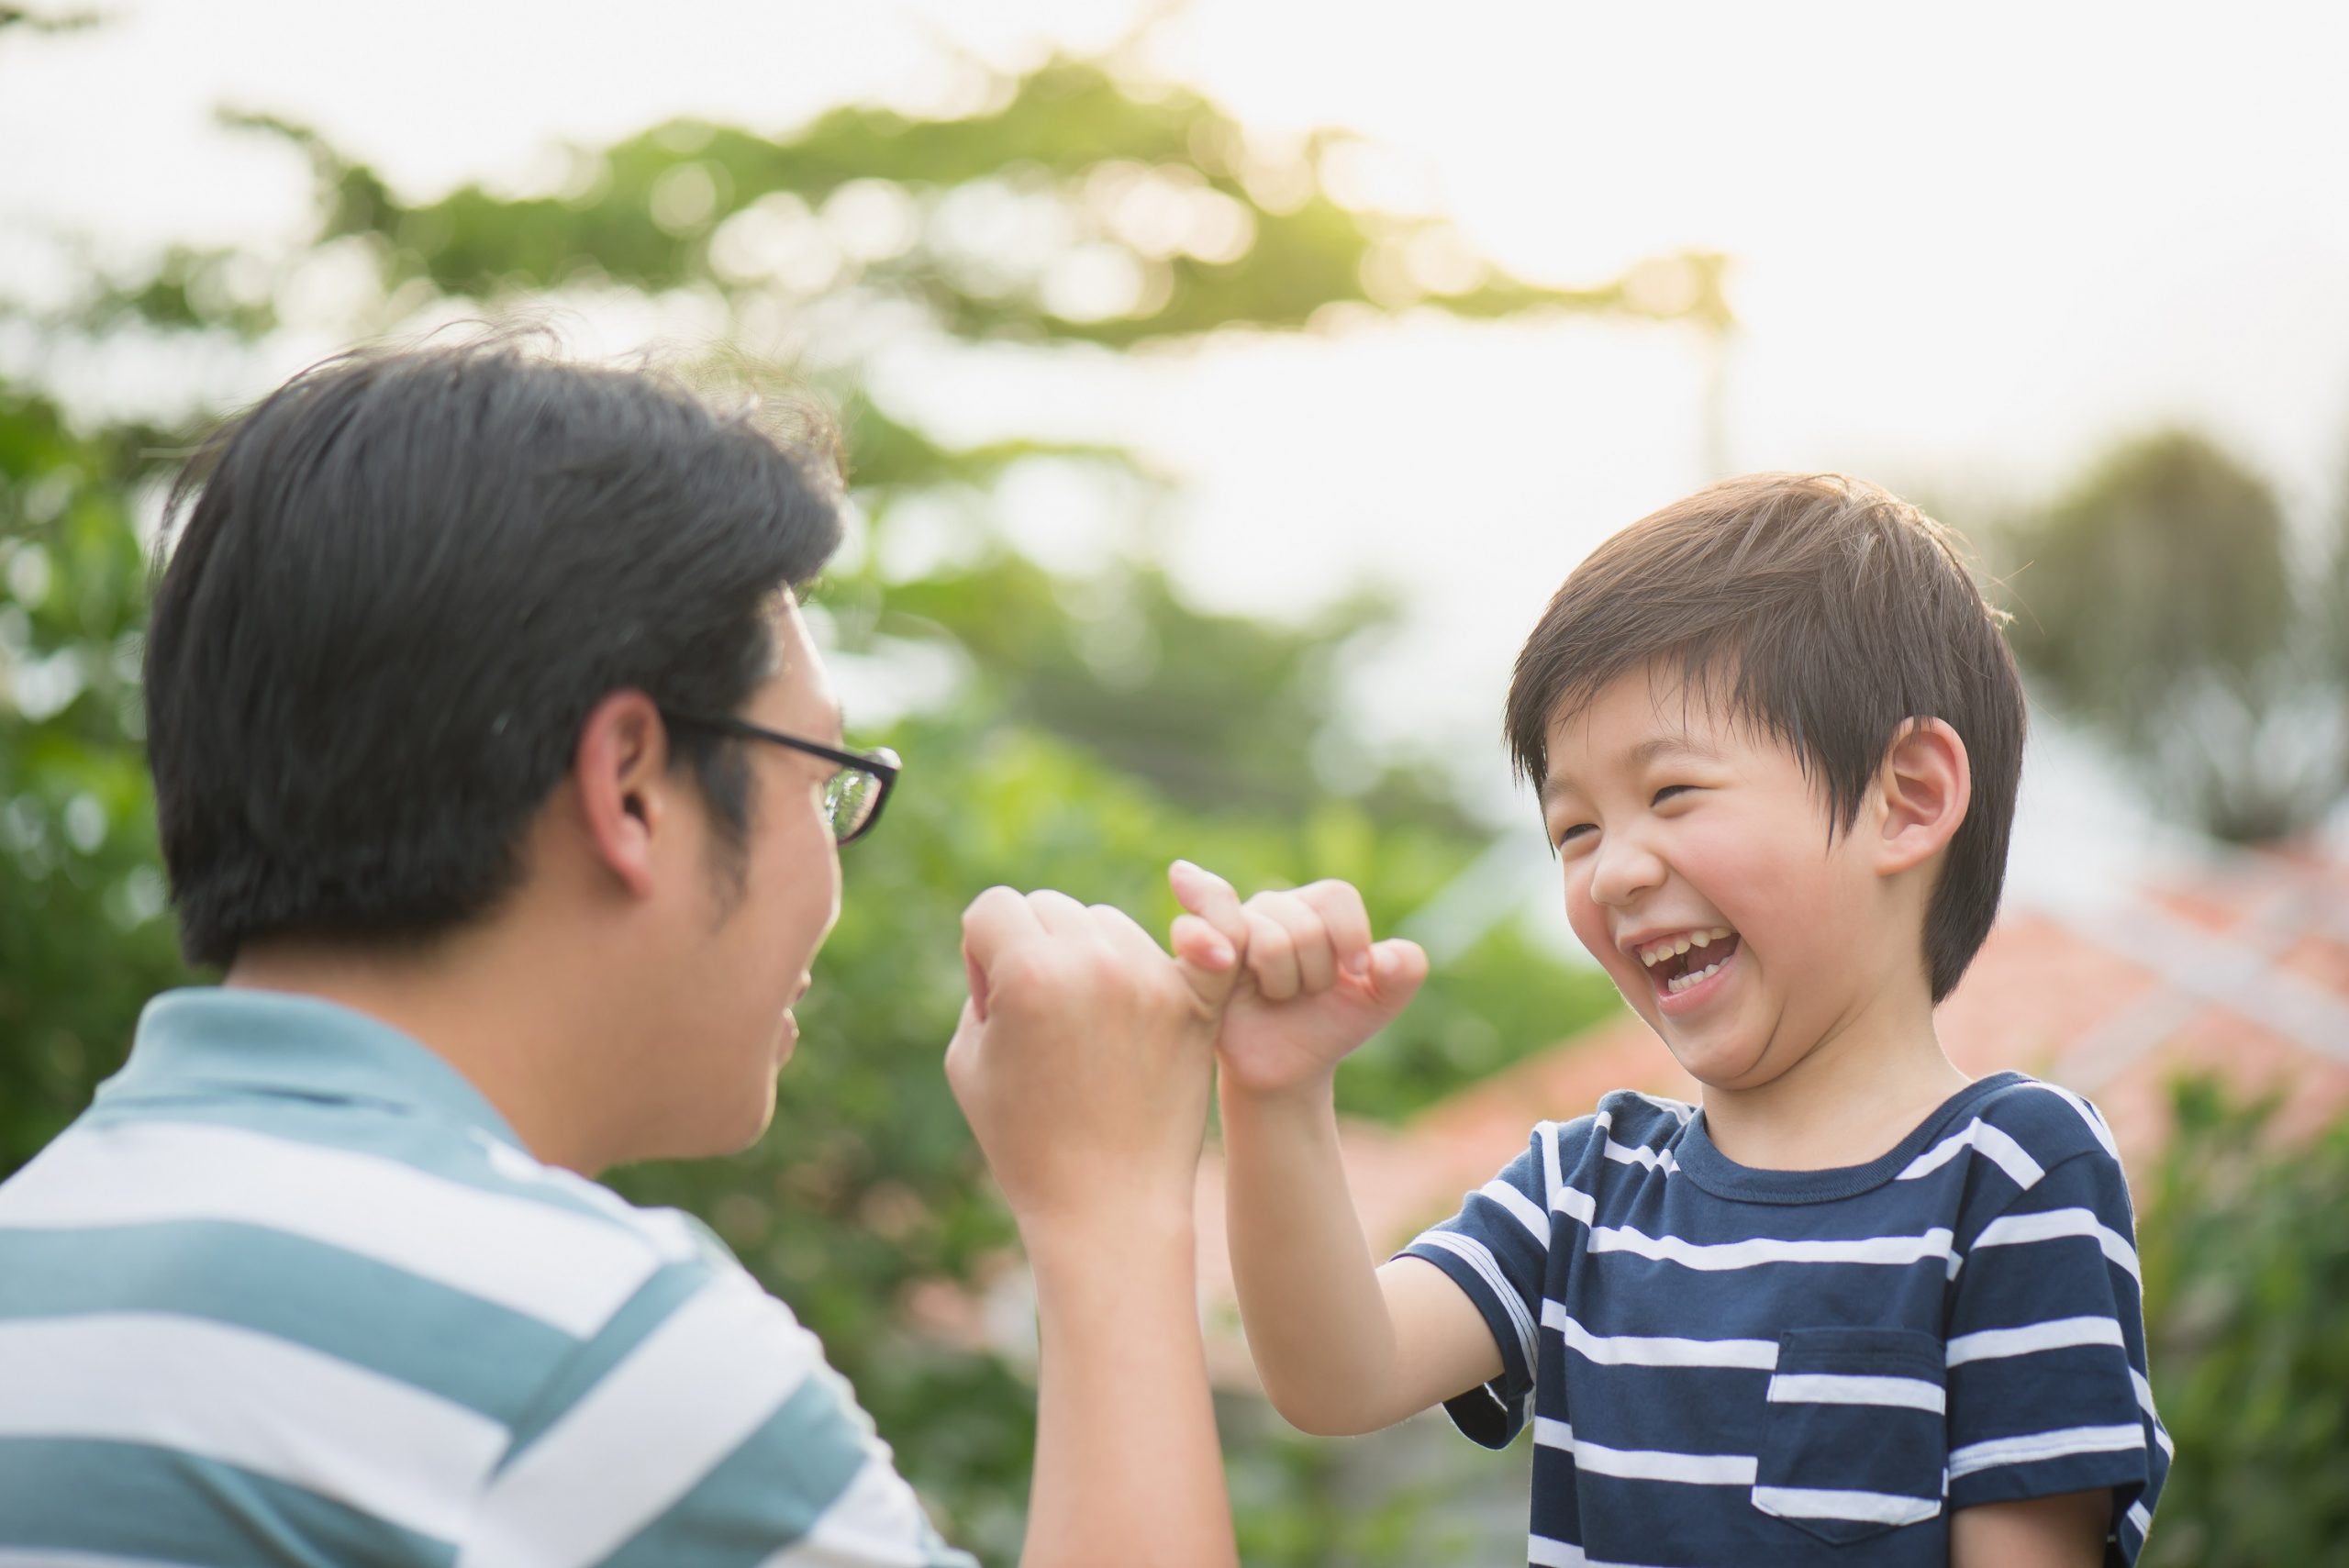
2004, 432, 2349, 842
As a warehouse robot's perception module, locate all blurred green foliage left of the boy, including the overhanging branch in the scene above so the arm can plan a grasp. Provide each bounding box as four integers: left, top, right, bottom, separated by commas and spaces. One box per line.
0, 33, 1663, 1563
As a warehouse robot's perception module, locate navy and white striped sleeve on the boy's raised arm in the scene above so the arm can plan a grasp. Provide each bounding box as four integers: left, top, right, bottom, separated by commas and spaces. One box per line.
1396, 1122, 1560, 1449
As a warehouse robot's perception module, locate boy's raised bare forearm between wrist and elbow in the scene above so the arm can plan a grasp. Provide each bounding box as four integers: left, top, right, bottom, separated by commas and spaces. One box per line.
1221, 1077, 1409, 1437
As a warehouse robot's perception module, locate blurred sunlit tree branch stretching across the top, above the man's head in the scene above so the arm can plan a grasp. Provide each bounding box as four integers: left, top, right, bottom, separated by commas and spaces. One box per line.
216, 61, 1691, 348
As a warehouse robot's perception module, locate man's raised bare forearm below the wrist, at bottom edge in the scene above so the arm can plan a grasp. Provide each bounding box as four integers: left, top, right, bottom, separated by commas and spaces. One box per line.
1019, 1193, 1238, 1568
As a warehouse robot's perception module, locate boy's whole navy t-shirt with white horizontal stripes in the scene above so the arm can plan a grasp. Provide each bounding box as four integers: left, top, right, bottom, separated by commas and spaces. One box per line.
1405, 1073, 2170, 1568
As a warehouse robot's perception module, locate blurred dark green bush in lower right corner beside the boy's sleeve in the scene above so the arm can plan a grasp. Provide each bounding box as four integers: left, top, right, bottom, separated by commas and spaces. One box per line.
2138, 1080, 2349, 1568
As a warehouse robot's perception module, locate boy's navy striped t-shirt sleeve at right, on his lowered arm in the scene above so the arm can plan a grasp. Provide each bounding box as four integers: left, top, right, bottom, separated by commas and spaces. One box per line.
1945, 1131, 2170, 1563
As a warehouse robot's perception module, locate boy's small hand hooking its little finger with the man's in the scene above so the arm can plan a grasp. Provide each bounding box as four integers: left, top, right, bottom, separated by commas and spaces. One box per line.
1172, 862, 1428, 1094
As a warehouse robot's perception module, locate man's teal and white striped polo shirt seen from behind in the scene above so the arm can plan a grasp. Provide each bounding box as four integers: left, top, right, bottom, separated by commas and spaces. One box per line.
0, 991, 970, 1568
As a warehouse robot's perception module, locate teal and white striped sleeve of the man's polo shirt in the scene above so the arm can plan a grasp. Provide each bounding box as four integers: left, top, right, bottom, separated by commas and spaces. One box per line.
461, 1265, 977, 1568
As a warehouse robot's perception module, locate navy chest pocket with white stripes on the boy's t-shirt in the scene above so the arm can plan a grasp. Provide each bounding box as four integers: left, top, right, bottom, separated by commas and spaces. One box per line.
1753, 1329, 1947, 1544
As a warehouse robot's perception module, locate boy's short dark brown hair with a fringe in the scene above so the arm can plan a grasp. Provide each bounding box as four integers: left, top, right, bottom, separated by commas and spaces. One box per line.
1506, 474, 2025, 1002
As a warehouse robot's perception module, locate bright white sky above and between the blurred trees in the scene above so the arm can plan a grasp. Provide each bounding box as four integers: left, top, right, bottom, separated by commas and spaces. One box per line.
0, 0, 2349, 919
